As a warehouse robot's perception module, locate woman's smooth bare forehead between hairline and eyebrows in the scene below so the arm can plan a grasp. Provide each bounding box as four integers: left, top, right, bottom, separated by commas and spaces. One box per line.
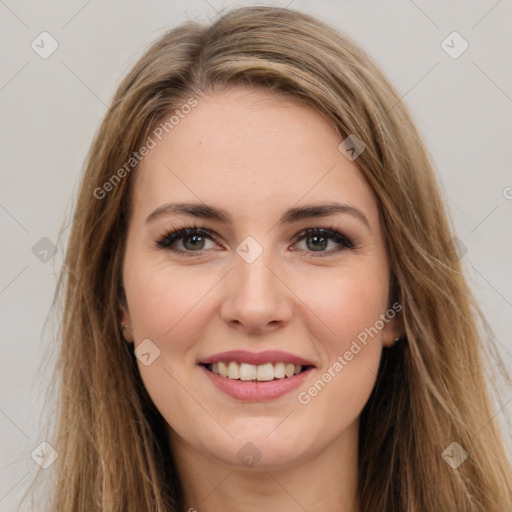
134, 89, 378, 227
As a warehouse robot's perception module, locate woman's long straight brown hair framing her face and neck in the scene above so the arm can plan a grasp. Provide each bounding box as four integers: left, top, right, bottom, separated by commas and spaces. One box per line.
21, 7, 512, 512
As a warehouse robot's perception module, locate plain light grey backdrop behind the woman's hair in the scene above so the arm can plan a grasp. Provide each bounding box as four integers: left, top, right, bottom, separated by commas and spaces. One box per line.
0, 0, 512, 511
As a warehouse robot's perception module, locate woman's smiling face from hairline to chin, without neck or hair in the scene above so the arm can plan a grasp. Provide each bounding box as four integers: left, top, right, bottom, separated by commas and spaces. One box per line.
123, 89, 400, 468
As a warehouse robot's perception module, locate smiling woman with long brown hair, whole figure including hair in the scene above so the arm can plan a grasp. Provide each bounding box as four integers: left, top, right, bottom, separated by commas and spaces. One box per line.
23, 7, 512, 512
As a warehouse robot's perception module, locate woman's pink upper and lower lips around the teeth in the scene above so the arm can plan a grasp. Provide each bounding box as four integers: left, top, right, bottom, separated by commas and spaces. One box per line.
198, 350, 315, 402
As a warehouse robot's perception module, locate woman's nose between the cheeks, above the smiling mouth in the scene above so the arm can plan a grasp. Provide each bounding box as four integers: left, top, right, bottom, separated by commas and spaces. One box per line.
221, 251, 293, 334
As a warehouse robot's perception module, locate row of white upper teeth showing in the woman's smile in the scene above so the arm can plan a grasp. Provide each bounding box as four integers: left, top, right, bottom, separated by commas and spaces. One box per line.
209, 361, 302, 382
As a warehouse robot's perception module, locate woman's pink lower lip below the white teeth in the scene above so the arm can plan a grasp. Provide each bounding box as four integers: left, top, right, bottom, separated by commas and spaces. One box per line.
199, 365, 313, 402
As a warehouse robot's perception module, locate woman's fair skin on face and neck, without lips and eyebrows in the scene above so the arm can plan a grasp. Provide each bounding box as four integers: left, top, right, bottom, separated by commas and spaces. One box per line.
123, 89, 401, 512
